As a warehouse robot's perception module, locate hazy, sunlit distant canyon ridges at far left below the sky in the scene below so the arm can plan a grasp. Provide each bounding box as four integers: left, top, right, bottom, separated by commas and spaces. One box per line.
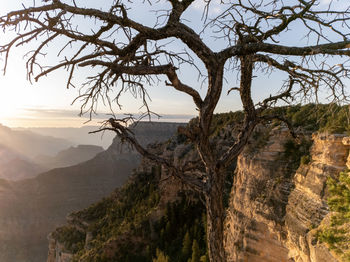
0, 124, 113, 181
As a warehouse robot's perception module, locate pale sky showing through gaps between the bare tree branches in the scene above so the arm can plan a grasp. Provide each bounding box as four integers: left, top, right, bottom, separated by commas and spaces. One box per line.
0, 0, 347, 127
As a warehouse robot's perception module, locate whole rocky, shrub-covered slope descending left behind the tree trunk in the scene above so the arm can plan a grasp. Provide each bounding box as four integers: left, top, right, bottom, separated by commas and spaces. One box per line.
47, 154, 206, 262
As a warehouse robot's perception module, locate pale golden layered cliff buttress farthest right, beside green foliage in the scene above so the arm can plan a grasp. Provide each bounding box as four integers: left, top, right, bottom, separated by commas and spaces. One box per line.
285, 135, 350, 262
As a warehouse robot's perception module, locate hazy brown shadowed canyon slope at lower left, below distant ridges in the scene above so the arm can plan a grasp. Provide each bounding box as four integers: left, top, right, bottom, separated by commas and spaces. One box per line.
0, 123, 179, 262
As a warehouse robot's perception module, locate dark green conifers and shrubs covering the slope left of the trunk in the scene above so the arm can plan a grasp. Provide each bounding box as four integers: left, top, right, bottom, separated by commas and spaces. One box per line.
53, 170, 207, 262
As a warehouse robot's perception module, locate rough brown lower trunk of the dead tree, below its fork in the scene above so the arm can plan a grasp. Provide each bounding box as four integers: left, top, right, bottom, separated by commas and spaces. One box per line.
206, 170, 226, 262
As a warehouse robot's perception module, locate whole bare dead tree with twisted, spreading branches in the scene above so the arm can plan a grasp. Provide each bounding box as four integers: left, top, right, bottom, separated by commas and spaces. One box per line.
0, 0, 350, 262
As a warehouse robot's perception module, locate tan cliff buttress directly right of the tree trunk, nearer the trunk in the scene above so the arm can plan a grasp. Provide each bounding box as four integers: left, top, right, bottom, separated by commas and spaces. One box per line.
225, 126, 293, 262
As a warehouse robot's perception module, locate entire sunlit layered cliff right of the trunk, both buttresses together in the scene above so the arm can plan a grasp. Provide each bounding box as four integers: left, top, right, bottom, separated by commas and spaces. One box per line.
225, 129, 349, 262
